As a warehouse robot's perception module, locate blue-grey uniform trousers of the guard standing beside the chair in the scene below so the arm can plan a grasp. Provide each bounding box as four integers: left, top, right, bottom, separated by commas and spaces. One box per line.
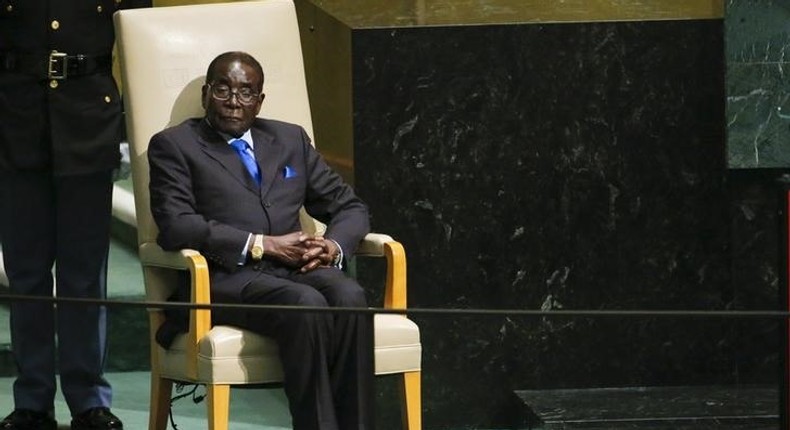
0, 172, 112, 414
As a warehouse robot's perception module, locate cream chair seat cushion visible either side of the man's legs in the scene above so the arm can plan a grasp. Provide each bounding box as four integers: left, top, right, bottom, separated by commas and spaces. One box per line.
158, 314, 422, 384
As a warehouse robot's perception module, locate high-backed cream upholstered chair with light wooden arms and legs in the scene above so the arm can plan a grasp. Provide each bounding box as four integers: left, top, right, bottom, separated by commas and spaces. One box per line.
115, 0, 421, 430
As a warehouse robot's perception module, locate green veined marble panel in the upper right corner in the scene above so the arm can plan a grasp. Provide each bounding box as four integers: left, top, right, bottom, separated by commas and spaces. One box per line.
725, 0, 790, 168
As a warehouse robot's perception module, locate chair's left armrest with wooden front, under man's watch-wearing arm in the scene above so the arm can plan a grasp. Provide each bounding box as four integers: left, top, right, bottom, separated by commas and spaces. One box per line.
139, 243, 211, 378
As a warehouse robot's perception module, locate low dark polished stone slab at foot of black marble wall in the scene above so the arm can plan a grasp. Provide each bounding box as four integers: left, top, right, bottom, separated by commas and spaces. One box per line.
516, 386, 779, 430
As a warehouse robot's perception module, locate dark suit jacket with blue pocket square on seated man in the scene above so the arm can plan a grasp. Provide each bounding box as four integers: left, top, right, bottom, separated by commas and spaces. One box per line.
148, 119, 370, 303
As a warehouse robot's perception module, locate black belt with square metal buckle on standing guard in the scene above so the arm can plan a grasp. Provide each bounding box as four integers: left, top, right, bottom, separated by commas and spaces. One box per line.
0, 51, 112, 79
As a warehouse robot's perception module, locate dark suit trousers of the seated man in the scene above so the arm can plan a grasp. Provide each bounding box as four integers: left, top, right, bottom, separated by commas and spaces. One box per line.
218, 268, 375, 430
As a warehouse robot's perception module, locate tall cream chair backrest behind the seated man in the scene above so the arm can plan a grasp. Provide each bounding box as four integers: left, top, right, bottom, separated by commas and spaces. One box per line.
115, 0, 313, 250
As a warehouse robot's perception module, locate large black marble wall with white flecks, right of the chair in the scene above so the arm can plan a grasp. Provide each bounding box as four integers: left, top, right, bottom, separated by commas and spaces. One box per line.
298, 3, 781, 429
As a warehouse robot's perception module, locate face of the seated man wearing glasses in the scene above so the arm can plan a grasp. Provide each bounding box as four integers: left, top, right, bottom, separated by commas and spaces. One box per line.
202, 59, 264, 137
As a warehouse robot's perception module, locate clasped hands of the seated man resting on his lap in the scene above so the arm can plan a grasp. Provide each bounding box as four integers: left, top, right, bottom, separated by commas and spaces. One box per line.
263, 231, 340, 273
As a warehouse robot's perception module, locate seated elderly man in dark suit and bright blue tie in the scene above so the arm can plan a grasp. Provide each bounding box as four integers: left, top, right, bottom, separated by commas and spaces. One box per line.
148, 52, 374, 430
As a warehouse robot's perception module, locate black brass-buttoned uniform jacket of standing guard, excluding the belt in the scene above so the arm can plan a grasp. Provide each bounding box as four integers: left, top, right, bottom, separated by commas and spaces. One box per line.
0, 0, 151, 175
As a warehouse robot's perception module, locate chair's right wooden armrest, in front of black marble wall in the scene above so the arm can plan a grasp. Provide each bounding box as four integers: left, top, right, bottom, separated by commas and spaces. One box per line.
356, 233, 407, 309
